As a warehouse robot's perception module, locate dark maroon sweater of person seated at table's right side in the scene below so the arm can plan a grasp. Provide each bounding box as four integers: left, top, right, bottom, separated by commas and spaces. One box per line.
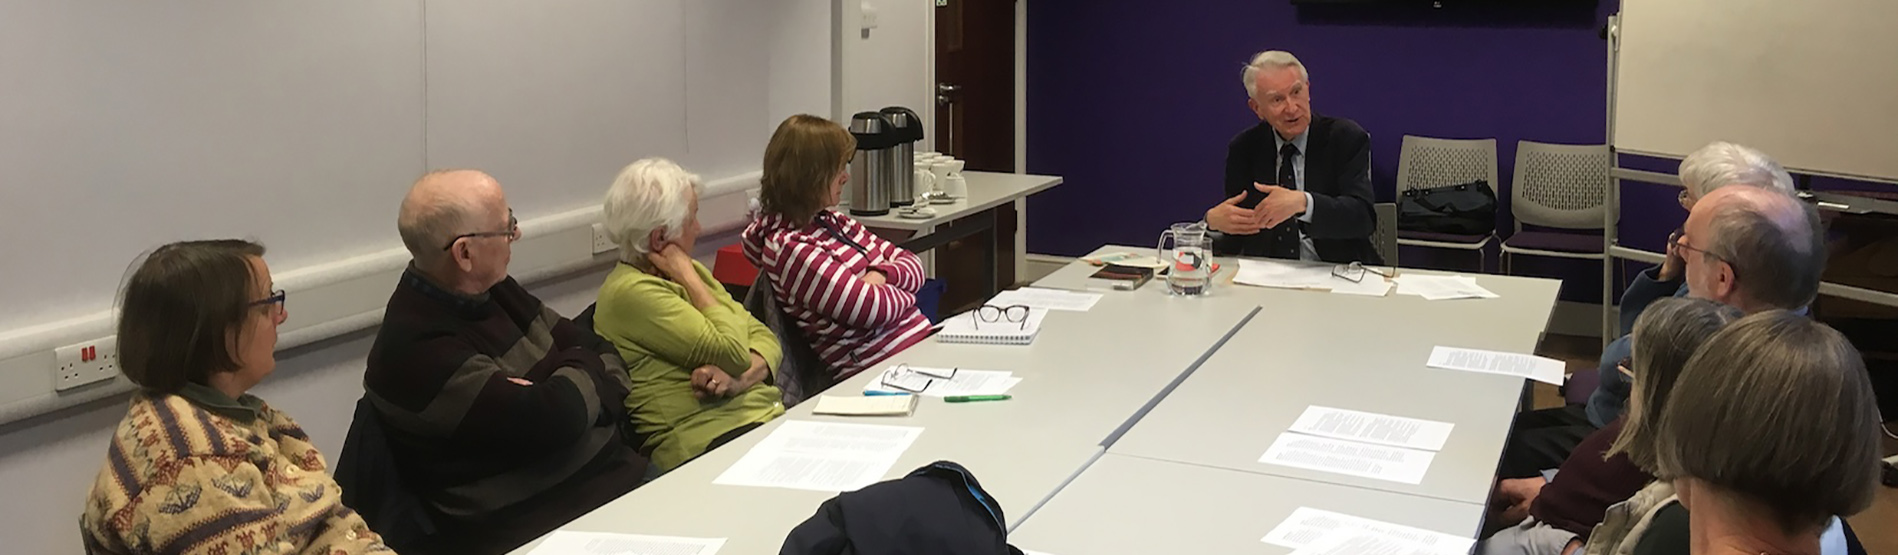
1530, 418, 1653, 542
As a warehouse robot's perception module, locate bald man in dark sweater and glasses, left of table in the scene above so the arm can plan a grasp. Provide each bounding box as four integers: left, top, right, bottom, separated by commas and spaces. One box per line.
363, 171, 647, 553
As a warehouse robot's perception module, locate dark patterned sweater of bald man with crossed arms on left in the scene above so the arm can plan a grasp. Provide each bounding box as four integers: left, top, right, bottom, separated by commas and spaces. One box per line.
363, 268, 645, 538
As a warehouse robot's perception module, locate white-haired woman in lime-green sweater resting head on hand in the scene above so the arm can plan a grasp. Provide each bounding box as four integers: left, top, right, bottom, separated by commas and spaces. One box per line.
594, 158, 784, 471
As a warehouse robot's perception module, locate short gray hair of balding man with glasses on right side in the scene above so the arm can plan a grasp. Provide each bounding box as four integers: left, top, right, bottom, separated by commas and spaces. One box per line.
1704, 192, 1826, 310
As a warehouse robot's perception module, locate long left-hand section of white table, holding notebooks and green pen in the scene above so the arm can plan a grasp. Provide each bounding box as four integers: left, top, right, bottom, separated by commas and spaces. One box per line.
516, 258, 1256, 553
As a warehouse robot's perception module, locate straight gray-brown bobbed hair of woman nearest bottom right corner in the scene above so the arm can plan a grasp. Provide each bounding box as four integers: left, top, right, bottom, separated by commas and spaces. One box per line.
1655, 310, 1879, 534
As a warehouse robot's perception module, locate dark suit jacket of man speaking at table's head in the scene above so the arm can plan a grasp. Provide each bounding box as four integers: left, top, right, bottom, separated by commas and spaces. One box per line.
1213, 114, 1384, 264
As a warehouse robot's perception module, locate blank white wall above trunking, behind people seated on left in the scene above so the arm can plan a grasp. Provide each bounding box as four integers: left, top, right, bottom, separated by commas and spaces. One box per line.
0, 0, 833, 336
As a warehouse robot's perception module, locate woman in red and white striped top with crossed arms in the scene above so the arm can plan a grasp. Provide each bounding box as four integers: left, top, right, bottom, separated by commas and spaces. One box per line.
744, 114, 930, 378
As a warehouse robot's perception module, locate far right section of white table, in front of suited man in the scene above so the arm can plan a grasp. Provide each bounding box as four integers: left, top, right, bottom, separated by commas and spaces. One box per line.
1108, 250, 1560, 504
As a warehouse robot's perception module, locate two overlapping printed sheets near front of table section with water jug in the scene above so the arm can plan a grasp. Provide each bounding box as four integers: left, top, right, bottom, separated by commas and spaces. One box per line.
1258, 407, 1454, 485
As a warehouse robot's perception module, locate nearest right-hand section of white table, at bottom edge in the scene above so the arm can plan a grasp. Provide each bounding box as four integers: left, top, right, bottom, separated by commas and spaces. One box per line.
1002, 452, 1482, 555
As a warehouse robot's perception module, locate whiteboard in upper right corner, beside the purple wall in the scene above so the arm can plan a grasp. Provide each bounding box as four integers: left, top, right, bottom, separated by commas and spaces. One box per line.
1613, 0, 1898, 181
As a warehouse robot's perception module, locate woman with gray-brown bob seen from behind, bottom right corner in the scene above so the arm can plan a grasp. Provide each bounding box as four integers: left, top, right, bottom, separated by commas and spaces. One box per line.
1589, 310, 1879, 555
